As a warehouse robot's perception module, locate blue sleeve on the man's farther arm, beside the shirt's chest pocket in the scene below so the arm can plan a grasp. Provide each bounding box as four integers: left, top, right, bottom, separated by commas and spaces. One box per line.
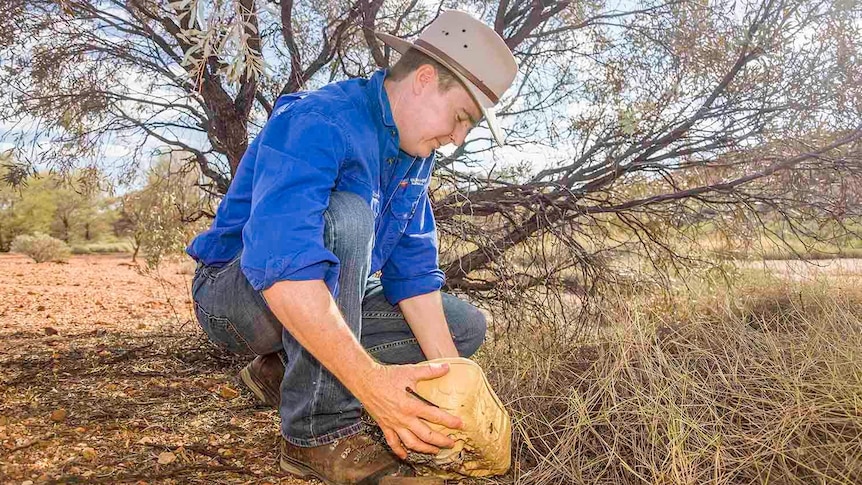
380, 190, 445, 305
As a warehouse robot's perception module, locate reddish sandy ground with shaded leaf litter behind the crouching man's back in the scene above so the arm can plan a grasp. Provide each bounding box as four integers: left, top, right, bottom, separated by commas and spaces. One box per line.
0, 254, 315, 484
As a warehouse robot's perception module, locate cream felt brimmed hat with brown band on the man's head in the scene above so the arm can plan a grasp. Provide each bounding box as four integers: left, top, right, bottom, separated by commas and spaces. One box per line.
375, 10, 518, 145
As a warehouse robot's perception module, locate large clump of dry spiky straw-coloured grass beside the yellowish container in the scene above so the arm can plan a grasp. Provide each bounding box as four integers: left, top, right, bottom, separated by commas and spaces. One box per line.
481, 274, 862, 484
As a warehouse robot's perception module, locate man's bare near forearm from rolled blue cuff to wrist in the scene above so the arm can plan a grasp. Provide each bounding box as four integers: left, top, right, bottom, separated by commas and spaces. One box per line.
263, 280, 378, 397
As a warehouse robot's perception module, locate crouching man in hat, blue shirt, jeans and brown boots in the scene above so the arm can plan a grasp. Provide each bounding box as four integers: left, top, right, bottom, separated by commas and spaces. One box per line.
188, 11, 517, 483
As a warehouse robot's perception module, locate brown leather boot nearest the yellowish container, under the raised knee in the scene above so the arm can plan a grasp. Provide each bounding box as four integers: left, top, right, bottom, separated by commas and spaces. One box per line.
281, 433, 413, 485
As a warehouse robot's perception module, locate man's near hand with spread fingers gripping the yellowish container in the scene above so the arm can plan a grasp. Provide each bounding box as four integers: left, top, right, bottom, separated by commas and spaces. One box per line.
352, 364, 463, 459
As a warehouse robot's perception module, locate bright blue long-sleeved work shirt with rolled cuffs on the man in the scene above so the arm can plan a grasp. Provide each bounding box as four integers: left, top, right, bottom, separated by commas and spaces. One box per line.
186, 70, 443, 305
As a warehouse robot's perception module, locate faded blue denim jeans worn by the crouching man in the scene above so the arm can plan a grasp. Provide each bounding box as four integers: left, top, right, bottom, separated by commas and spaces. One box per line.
192, 192, 485, 446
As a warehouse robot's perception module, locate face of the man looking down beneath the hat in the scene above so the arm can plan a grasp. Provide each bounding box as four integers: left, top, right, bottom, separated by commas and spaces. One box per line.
397, 65, 482, 157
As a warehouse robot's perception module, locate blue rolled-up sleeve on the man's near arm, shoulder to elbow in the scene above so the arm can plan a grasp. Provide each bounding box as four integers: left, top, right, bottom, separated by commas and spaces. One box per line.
240, 113, 350, 295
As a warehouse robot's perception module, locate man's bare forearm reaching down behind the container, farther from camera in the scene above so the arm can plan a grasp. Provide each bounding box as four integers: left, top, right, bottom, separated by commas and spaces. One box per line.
398, 291, 458, 359
